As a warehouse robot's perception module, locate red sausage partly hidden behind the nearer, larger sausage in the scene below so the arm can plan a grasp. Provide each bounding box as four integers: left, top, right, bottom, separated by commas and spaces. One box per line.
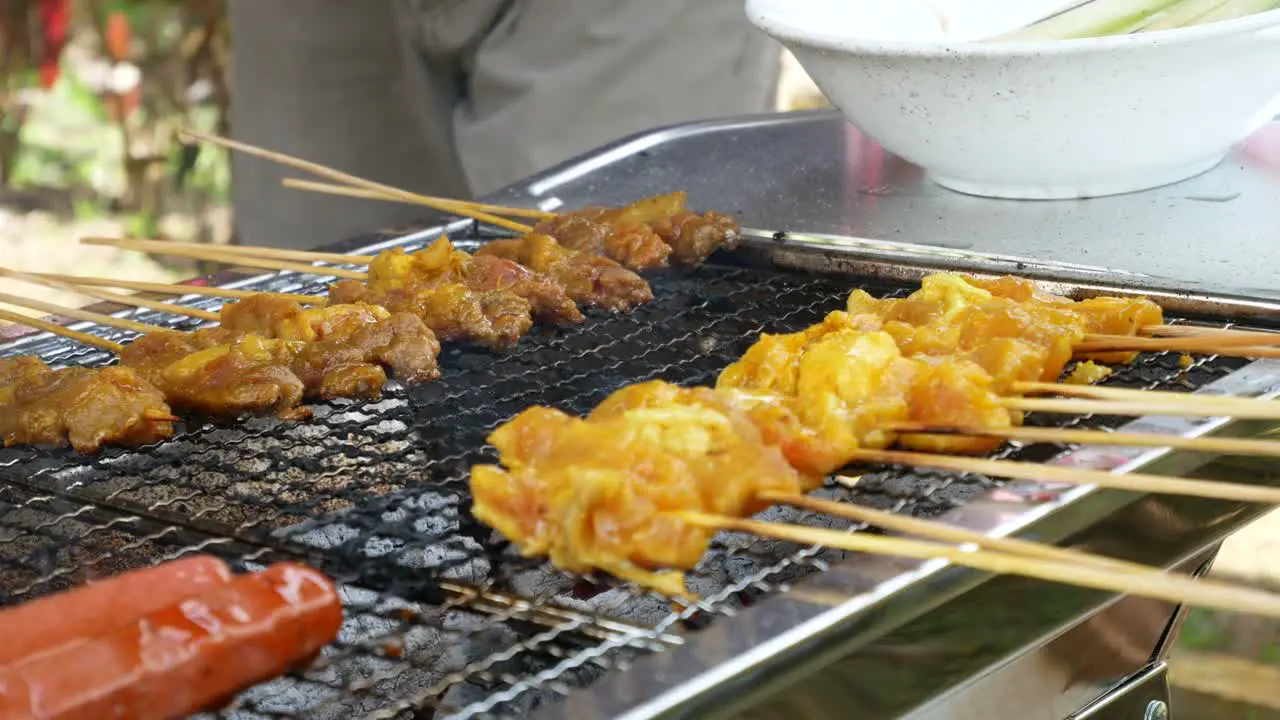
0, 555, 232, 667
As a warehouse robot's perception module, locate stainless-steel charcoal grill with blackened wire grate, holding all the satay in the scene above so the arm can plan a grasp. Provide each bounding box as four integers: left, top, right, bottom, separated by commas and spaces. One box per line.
0, 107, 1280, 720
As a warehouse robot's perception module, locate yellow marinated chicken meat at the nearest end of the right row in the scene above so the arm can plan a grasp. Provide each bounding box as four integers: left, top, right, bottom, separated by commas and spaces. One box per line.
471, 381, 814, 594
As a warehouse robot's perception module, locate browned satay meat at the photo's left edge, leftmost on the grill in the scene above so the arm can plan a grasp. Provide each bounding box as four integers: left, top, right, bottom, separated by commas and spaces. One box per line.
0, 357, 175, 454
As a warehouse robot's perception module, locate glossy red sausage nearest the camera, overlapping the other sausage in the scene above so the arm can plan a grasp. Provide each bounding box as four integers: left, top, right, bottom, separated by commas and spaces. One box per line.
0, 562, 342, 720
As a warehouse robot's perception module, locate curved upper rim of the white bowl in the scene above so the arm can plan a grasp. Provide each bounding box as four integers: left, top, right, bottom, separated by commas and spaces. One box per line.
746, 0, 1280, 58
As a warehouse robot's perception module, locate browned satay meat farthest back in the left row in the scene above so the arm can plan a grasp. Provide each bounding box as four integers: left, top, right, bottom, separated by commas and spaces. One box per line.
475, 233, 653, 311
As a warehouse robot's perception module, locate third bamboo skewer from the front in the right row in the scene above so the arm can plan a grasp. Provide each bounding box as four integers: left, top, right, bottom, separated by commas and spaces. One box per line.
851, 450, 1280, 505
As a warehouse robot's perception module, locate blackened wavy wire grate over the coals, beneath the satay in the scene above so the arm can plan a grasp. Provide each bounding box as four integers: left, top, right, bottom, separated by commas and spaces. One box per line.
0, 233, 1247, 719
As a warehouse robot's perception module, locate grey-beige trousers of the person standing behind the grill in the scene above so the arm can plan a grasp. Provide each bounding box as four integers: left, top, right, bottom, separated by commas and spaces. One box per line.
230, 0, 778, 247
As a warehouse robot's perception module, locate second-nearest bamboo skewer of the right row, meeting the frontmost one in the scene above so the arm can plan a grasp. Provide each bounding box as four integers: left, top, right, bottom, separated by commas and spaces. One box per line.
760, 492, 1152, 573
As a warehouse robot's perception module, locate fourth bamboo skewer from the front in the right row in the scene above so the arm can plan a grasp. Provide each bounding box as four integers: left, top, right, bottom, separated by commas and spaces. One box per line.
884, 423, 1280, 457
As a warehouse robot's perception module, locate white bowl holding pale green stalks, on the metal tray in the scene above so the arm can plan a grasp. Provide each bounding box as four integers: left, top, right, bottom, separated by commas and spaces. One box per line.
746, 0, 1280, 199
